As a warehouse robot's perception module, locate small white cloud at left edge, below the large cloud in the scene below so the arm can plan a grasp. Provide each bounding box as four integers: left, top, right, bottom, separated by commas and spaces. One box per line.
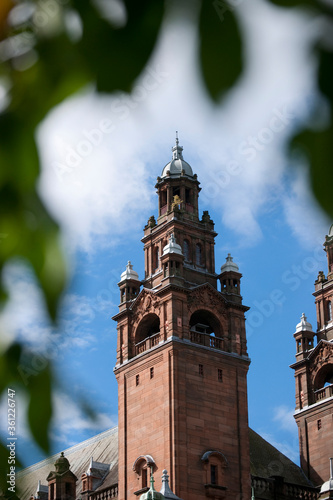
0, 262, 107, 360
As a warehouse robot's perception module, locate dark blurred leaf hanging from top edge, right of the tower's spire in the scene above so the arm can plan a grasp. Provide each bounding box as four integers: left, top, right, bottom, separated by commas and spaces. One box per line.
199, 0, 243, 101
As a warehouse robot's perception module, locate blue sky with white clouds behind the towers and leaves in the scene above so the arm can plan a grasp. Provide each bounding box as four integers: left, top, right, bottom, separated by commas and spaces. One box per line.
1, 0, 330, 465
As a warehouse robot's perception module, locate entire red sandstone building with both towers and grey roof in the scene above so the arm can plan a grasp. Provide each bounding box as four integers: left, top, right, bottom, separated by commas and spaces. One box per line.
13, 139, 333, 500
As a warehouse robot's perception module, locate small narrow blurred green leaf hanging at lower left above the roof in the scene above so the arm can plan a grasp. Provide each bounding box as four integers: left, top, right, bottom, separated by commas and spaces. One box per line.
28, 365, 52, 453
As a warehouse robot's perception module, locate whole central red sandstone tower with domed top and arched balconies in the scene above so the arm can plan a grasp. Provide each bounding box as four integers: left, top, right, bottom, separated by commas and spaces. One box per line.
114, 139, 250, 500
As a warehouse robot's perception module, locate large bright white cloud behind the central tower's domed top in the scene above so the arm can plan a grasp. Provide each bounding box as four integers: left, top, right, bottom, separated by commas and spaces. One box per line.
34, 0, 322, 252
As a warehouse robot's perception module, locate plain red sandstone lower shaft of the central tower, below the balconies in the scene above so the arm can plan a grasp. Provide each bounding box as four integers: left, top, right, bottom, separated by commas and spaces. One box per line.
117, 342, 250, 500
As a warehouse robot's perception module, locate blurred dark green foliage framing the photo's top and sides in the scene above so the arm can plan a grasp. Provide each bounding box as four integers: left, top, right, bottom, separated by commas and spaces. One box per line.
0, 0, 333, 488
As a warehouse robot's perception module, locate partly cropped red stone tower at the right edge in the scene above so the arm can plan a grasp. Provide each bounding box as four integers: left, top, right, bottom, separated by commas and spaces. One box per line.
292, 225, 333, 485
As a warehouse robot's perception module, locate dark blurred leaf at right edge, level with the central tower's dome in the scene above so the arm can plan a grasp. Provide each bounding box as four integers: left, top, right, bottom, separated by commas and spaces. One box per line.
291, 122, 333, 219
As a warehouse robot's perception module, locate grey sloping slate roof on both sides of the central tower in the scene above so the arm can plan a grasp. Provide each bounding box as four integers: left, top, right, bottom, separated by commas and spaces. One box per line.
17, 427, 311, 500
